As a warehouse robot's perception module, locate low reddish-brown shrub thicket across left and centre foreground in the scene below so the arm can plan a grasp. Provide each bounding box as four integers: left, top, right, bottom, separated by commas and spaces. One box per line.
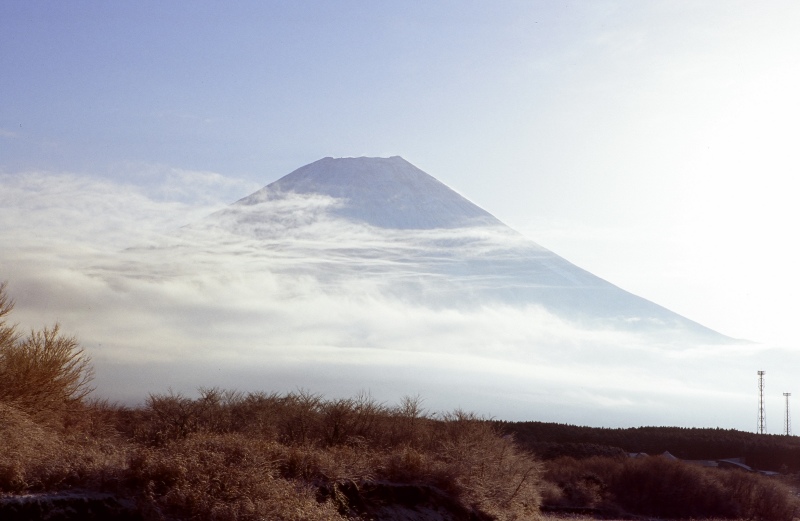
0, 392, 540, 520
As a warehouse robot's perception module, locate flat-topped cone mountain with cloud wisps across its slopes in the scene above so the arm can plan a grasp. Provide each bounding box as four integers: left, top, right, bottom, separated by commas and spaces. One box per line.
169, 156, 732, 344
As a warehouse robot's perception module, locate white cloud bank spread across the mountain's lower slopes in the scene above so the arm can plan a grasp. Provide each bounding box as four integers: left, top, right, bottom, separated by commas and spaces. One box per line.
0, 173, 771, 428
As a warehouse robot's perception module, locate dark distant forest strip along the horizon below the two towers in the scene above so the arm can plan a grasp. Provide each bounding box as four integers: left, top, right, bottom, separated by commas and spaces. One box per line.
497, 422, 800, 472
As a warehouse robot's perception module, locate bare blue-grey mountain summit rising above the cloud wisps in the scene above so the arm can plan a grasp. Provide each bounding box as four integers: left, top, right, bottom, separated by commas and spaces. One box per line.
237, 156, 502, 229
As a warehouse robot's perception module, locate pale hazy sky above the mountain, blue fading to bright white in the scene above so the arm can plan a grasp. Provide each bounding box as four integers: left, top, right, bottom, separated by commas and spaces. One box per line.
0, 0, 800, 428
